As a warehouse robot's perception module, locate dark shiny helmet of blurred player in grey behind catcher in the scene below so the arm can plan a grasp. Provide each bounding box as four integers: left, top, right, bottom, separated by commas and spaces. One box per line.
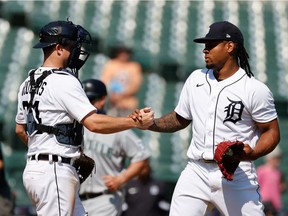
82, 79, 107, 101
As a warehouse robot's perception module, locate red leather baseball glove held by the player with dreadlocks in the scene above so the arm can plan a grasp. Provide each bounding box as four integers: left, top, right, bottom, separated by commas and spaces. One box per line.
214, 140, 244, 181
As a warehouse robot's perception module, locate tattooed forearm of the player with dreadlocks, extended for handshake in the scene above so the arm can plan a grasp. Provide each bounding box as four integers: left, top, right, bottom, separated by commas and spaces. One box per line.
149, 111, 191, 133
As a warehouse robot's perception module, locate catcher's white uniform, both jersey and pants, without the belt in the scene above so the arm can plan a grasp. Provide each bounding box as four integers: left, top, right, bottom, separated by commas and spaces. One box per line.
16, 67, 96, 216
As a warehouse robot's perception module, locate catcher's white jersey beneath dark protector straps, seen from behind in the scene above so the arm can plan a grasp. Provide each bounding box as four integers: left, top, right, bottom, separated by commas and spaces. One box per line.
16, 67, 96, 158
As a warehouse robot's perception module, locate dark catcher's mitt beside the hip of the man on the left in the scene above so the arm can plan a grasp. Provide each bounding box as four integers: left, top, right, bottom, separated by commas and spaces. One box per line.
73, 153, 95, 184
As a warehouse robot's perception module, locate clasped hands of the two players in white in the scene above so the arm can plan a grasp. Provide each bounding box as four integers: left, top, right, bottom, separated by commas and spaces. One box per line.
128, 107, 154, 130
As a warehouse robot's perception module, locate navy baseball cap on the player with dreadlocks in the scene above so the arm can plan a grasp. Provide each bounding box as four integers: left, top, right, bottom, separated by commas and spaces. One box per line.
194, 21, 244, 44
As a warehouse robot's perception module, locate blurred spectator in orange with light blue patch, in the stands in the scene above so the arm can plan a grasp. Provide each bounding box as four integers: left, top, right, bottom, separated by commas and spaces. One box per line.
100, 47, 143, 116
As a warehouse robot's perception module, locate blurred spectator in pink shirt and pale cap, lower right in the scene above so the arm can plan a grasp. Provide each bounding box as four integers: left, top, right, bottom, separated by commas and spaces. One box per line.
257, 146, 286, 216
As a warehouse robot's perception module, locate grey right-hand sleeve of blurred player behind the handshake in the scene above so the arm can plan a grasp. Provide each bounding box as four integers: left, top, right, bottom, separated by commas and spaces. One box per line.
119, 130, 150, 163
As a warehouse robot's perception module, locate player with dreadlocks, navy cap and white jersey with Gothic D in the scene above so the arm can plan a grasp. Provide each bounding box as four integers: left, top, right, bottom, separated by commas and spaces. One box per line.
134, 21, 280, 216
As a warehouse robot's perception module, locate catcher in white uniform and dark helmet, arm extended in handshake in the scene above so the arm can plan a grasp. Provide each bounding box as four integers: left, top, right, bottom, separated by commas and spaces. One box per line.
15, 20, 153, 216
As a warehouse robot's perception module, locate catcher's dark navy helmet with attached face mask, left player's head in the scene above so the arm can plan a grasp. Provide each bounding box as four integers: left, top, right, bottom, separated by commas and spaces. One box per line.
34, 21, 91, 73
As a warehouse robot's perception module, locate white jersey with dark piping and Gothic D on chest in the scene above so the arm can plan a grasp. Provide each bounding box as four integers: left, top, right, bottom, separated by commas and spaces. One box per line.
175, 69, 277, 160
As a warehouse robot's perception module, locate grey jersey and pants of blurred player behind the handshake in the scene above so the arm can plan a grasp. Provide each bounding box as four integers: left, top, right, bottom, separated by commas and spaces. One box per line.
79, 129, 149, 216
